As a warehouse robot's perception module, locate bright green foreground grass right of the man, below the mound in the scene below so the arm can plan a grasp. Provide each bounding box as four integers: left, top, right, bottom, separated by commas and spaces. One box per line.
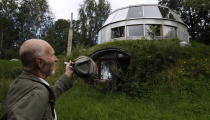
56, 81, 210, 120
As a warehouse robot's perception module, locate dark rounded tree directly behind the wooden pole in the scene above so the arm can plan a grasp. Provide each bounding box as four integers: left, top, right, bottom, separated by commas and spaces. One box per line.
43, 19, 82, 55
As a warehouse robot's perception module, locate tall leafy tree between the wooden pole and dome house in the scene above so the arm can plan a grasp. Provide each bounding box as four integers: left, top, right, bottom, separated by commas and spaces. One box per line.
79, 0, 110, 46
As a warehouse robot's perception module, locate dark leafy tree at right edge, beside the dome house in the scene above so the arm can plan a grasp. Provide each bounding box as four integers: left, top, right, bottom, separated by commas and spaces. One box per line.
182, 0, 210, 44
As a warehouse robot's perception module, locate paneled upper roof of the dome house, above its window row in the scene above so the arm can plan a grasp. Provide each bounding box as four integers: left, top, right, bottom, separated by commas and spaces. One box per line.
103, 4, 184, 27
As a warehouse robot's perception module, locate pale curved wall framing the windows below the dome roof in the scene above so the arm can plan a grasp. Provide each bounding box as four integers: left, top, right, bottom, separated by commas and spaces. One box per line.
98, 18, 189, 44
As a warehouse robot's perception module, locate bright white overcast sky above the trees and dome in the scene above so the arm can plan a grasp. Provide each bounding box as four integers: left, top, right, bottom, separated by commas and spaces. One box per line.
48, 0, 158, 20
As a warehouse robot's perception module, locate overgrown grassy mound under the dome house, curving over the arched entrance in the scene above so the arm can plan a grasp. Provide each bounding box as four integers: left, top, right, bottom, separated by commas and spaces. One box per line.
66, 40, 210, 97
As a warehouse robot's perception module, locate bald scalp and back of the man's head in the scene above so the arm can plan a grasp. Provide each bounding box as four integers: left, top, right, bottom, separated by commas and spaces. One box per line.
19, 39, 51, 68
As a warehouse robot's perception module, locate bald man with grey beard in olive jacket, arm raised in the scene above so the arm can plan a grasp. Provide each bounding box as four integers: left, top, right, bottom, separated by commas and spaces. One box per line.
3, 39, 73, 120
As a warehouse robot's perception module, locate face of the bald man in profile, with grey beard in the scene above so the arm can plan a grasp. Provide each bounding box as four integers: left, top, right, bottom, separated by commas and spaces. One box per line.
42, 46, 58, 76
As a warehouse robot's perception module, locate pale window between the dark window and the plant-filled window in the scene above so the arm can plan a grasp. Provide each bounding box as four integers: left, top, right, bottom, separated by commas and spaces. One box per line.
127, 25, 144, 36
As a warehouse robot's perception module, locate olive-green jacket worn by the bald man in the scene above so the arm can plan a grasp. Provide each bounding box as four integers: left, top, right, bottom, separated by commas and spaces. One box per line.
6, 72, 72, 120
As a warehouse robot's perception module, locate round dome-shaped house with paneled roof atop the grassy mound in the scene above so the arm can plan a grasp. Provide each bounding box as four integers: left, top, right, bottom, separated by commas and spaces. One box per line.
98, 4, 189, 44
